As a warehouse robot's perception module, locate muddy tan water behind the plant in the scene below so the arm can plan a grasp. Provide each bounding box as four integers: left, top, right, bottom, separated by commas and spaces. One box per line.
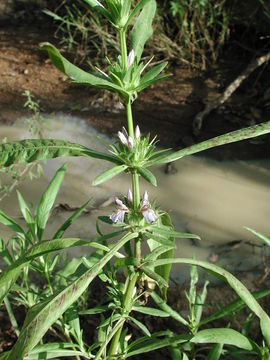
0, 114, 270, 278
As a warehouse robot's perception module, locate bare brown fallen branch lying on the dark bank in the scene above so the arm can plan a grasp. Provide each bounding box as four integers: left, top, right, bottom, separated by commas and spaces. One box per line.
193, 52, 270, 135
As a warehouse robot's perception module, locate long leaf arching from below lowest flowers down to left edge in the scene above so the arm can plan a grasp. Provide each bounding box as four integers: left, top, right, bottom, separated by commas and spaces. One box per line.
0, 231, 122, 304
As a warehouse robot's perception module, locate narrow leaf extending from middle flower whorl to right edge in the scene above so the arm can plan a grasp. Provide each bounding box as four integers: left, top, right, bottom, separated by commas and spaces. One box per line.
151, 121, 270, 166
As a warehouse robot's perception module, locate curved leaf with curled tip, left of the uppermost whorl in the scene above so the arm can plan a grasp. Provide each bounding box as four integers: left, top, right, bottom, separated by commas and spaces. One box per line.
41, 43, 128, 97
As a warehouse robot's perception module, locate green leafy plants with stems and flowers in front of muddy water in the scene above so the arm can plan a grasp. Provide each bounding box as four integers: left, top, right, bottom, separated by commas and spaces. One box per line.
0, 0, 270, 360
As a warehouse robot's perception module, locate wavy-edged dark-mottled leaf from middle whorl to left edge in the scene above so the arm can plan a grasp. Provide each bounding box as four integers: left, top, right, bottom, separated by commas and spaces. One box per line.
0, 139, 120, 168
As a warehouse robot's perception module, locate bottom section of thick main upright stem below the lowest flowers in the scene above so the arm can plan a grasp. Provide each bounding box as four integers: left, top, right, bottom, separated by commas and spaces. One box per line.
108, 273, 139, 359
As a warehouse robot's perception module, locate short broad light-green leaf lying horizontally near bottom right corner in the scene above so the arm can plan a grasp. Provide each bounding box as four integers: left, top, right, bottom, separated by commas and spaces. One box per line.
190, 328, 253, 350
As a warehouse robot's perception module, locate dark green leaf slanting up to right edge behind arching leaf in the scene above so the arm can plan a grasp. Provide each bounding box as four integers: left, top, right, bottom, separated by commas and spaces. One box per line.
200, 289, 270, 326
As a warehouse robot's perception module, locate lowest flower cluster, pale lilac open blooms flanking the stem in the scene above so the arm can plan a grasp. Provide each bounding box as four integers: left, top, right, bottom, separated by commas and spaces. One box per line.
110, 189, 157, 224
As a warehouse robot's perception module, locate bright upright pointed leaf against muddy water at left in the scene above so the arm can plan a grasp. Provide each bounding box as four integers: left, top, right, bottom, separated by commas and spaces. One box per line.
36, 165, 66, 240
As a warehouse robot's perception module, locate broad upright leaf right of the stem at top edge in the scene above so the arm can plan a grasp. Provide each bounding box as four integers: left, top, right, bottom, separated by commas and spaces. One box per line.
130, 0, 157, 63
